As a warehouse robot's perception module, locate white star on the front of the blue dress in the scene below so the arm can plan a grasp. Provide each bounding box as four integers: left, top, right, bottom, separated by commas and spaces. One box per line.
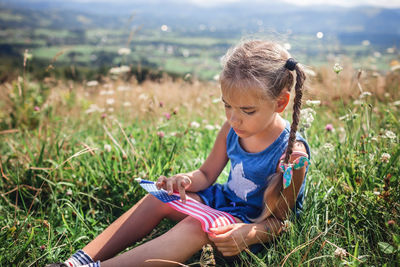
228, 162, 257, 201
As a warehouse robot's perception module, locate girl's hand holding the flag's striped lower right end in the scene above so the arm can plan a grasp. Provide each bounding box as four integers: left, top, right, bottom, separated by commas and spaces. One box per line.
208, 223, 253, 256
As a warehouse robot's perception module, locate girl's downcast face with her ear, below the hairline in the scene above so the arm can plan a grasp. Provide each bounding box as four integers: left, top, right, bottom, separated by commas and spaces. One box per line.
222, 86, 289, 138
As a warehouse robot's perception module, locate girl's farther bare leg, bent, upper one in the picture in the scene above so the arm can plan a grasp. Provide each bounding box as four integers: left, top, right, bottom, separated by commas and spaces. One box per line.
83, 195, 186, 266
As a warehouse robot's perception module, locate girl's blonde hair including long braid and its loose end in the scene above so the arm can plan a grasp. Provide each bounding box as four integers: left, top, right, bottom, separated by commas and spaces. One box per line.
220, 40, 306, 222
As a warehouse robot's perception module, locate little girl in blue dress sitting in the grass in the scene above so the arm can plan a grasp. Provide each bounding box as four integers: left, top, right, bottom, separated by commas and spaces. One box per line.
49, 40, 310, 267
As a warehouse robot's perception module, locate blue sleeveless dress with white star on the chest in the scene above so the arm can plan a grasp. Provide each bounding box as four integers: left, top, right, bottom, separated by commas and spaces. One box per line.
197, 121, 310, 223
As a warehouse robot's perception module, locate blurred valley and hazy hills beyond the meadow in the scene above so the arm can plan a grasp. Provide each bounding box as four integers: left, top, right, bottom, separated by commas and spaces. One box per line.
0, 0, 400, 82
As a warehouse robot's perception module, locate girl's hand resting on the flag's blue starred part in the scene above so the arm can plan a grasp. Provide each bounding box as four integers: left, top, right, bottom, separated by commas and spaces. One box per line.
156, 173, 192, 202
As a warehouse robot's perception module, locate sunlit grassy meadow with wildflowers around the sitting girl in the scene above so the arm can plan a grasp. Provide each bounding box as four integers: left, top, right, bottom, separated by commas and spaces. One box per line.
0, 55, 400, 266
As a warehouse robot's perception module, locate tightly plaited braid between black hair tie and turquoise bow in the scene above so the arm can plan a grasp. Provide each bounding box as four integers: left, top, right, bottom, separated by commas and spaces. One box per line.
284, 64, 306, 163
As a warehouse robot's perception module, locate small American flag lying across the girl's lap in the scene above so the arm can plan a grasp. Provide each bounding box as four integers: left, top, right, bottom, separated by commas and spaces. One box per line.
136, 178, 236, 233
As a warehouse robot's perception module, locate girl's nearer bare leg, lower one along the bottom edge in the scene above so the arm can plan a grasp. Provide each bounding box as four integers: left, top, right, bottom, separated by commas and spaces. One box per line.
101, 216, 210, 267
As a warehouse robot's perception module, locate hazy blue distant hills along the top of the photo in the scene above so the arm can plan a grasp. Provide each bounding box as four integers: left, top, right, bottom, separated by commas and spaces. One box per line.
0, 0, 400, 40
